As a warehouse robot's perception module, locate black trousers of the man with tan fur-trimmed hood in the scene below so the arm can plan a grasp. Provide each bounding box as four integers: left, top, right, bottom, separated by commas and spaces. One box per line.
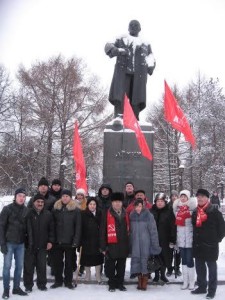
53, 245, 75, 284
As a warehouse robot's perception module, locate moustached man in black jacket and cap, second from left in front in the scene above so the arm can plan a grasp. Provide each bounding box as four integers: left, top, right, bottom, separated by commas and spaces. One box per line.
23, 194, 54, 293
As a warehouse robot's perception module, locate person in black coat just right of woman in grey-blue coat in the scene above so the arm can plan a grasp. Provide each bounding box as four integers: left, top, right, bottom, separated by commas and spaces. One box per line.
151, 193, 176, 283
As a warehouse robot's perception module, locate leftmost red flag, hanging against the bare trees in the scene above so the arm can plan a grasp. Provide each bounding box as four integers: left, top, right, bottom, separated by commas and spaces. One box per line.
73, 122, 87, 192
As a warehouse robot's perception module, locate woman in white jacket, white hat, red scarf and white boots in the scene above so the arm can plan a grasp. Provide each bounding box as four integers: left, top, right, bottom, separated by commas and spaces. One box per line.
173, 190, 197, 290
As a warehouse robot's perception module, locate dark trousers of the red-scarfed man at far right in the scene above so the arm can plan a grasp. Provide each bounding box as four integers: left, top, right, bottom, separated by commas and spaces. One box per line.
195, 258, 217, 294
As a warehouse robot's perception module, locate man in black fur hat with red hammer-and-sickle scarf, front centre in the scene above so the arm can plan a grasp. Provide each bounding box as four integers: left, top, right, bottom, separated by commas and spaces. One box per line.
100, 192, 129, 292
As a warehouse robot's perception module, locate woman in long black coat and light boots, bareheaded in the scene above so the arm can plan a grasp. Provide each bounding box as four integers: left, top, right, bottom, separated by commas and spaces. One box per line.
80, 197, 103, 284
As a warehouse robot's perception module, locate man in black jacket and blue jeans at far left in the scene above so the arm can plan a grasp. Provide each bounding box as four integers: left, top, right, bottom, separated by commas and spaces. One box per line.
0, 188, 32, 299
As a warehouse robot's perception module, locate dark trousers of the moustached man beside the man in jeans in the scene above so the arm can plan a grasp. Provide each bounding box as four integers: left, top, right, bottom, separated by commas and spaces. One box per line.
23, 249, 47, 288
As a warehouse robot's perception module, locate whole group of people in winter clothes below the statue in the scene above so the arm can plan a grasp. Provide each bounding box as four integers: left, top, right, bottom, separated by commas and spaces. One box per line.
0, 177, 225, 299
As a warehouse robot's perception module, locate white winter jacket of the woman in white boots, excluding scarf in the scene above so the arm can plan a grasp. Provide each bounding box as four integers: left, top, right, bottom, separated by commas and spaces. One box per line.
173, 198, 197, 248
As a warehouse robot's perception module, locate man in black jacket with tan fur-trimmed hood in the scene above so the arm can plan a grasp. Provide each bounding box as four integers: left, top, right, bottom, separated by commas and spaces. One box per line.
51, 189, 81, 289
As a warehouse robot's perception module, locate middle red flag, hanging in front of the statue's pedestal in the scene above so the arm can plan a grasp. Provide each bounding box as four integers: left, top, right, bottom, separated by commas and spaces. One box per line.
123, 95, 152, 160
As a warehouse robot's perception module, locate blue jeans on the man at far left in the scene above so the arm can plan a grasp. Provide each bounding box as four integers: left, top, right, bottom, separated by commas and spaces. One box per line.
2, 243, 24, 290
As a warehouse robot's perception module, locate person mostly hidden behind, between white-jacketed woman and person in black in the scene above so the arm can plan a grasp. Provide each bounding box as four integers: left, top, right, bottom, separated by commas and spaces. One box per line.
166, 190, 182, 277
